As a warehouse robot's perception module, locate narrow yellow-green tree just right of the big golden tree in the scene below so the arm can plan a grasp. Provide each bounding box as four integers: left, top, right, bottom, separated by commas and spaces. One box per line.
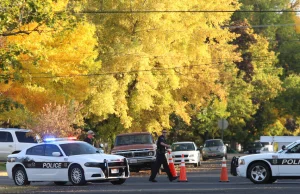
228, 20, 281, 141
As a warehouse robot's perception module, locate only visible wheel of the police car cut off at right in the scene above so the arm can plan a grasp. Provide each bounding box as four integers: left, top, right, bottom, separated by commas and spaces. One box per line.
248, 162, 271, 184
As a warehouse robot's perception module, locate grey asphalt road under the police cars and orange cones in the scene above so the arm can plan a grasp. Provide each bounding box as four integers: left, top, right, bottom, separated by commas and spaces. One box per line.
0, 156, 300, 194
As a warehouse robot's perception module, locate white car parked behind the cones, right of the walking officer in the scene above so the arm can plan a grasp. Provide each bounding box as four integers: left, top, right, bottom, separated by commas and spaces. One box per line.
172, 141, 201, 167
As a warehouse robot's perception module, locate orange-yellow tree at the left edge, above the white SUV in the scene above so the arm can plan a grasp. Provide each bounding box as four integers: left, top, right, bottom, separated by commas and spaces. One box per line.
0, 0, 101, 130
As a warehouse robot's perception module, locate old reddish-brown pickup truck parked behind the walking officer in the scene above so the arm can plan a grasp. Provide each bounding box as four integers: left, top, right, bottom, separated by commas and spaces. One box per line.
111, 132, 156, 172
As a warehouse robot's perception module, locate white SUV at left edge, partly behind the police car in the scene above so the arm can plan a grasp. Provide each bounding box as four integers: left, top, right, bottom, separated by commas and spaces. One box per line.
0, 128, 37, 162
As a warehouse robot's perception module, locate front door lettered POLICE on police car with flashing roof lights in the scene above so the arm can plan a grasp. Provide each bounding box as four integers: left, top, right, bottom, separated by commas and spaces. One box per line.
41, 144, 68, 181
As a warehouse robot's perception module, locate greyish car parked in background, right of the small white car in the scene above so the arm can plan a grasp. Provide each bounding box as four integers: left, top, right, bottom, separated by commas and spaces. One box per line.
202, 139, 227, 161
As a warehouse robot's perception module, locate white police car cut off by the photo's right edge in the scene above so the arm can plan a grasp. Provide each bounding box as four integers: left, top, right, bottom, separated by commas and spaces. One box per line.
231, 140, 300, 184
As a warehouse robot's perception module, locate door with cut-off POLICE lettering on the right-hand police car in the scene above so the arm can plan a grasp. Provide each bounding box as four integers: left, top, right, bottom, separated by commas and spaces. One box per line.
279, 144, 300, 176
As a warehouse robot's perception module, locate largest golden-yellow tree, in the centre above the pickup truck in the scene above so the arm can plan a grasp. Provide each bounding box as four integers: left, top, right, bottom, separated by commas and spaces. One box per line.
87, 0, 239, 138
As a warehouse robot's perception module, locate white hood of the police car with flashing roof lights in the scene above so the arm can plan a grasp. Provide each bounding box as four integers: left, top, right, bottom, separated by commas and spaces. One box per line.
69, 154, 124, 162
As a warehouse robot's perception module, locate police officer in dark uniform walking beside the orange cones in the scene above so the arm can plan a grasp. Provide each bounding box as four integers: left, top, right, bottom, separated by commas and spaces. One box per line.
149, 129, 177, 182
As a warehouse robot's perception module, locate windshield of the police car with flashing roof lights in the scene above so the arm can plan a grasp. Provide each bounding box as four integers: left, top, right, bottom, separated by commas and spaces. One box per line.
60, 143, 99, 156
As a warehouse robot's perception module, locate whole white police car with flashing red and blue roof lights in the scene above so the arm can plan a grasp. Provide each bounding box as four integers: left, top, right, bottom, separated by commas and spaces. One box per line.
6, 139, 130, 186
